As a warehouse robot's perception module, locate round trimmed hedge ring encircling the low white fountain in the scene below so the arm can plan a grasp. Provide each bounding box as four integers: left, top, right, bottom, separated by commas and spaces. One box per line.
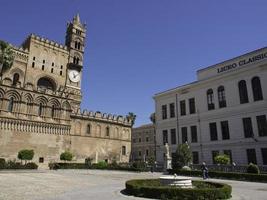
125, 179, 232, 200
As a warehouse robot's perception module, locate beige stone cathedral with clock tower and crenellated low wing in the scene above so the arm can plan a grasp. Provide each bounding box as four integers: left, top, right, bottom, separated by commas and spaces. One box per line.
0, 15, 132, 166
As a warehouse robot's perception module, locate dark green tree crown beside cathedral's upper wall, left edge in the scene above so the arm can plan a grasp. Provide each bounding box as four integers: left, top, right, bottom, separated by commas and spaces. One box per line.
0, 40, 14, 77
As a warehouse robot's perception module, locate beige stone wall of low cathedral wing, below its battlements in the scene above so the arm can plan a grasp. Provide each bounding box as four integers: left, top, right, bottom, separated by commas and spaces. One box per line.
71, 117, 131, 162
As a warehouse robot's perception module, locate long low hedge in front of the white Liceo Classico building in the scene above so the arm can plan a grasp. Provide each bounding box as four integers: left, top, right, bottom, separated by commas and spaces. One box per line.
169, 170, 267, 183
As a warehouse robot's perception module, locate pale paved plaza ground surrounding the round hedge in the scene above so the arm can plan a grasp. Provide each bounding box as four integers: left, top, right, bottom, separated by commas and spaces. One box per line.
0, 170, 267, 200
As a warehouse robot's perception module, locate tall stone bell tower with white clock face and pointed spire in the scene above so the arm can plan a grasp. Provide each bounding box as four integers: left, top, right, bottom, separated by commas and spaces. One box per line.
65, 14, 86, 107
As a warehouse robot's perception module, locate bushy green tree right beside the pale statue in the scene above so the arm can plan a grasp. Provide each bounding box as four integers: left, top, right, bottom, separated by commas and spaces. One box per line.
172, 143, 192, 169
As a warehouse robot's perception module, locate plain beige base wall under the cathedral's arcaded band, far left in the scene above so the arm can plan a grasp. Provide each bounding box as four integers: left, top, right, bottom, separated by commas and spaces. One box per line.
0, 130, 70, 165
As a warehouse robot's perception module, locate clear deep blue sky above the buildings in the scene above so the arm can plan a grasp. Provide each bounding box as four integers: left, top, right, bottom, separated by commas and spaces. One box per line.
0, 0, 267, 126
